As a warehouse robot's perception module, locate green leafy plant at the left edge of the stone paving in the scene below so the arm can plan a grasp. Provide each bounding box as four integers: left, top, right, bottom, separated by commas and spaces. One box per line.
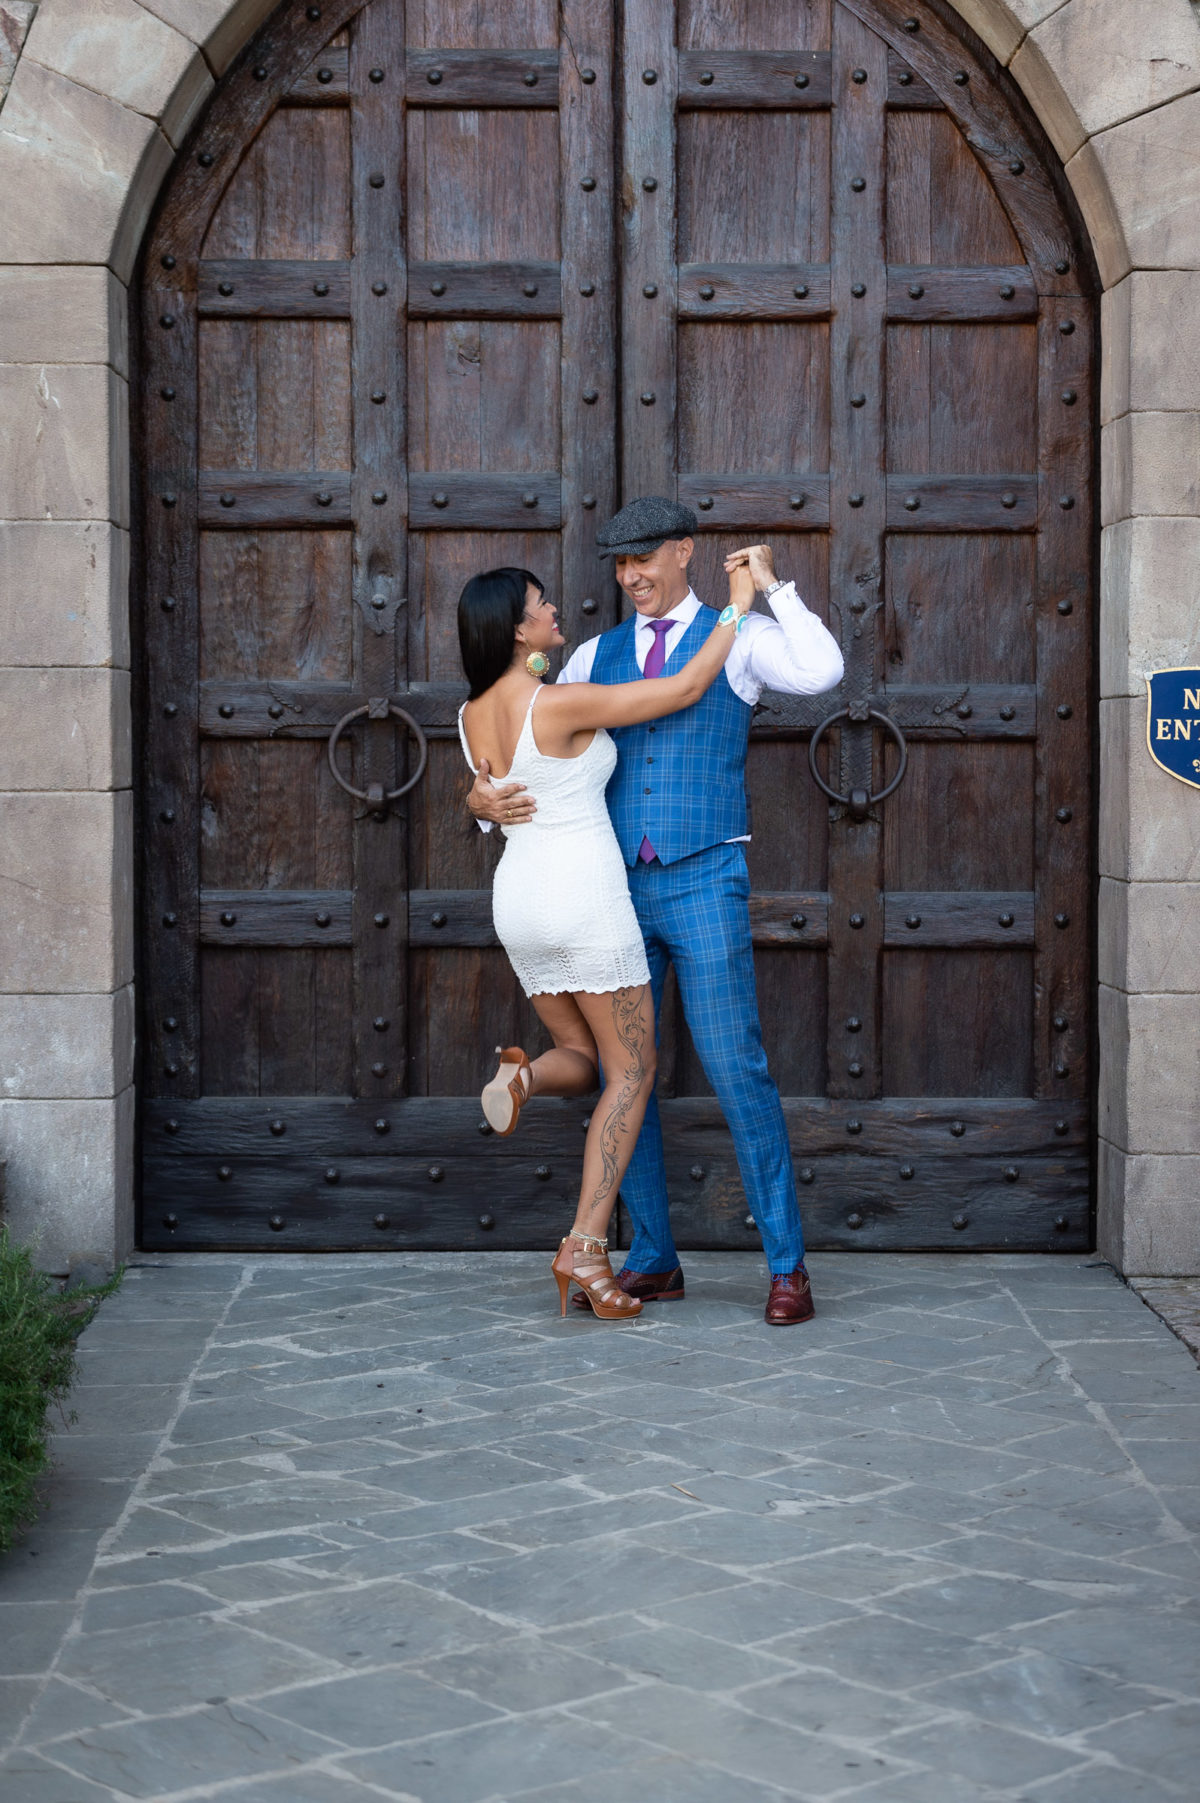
0, 1228, 123, 1552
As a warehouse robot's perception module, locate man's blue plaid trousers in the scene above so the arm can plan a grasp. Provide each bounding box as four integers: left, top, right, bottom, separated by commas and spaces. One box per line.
622, 846, 804, 1277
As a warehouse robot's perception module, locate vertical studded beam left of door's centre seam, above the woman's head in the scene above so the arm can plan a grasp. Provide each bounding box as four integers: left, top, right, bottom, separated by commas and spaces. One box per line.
559, 0, 616, 644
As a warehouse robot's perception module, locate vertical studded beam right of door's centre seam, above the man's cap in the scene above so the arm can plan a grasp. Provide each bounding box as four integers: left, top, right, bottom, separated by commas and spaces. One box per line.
620, 0, 677, 501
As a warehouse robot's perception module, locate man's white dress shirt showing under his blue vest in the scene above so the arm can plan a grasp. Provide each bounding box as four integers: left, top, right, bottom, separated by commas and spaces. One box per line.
559, 582, 841, 707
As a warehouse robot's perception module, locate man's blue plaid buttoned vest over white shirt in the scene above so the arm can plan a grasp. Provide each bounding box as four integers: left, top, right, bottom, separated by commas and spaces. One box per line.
591, 606, 753, 865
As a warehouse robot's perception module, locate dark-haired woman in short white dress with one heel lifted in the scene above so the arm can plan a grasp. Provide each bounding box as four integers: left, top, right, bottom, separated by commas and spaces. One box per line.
458, 566, 755, 1320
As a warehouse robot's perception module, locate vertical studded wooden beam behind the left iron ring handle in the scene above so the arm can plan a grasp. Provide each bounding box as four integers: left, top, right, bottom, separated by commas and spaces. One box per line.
348, 0, 409, 1098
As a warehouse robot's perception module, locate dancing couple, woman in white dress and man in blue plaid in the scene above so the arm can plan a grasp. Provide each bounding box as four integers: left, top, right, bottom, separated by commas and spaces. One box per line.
458, 496, 841, 1327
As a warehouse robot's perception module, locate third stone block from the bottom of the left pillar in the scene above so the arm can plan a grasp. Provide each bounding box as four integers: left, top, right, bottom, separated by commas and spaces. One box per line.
0, 790, 133, 995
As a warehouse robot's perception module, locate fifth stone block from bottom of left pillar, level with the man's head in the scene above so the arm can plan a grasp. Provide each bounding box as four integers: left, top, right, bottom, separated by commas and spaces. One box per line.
0, 519, 130, 667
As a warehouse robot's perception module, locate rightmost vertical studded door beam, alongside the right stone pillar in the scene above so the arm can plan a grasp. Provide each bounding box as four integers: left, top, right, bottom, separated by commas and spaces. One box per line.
1032, 296, 1094, 1102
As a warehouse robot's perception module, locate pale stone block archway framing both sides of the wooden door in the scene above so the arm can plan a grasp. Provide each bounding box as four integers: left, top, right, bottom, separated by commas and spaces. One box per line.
0, 0, 1200, 1273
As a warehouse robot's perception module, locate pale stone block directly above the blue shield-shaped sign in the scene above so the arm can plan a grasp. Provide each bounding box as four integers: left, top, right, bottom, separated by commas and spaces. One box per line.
1101, 517, 1200, 696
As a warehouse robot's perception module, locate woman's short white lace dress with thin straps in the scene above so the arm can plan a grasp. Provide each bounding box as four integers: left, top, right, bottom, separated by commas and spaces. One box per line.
458, 689, 650, 995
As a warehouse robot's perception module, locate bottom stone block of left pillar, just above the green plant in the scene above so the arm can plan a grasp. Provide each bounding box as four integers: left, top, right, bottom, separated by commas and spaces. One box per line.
0, 1089, 133, 1273
